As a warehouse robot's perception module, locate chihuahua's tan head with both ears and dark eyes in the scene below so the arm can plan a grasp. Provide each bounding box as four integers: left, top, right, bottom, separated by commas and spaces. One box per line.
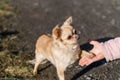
52, 17, 78, 44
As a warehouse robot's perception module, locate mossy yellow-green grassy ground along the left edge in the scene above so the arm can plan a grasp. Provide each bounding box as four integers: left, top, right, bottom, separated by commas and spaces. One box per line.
0, 0, 32, 80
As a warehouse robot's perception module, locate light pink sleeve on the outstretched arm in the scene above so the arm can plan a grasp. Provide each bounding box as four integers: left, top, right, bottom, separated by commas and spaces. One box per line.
101, 37, 120, 61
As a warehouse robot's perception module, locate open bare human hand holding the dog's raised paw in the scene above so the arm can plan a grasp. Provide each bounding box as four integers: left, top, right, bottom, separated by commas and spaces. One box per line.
79, 41, 104, 66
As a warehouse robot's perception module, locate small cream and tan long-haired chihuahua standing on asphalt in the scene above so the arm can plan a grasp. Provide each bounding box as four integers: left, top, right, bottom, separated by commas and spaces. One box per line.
33, 17, 80, 80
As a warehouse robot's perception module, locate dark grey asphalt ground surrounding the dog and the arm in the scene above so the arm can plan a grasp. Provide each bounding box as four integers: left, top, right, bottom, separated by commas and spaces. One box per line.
11, 0, 120, 80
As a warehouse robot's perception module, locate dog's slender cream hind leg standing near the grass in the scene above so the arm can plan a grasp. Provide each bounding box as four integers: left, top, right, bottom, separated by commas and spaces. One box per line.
33, 53, 45, 75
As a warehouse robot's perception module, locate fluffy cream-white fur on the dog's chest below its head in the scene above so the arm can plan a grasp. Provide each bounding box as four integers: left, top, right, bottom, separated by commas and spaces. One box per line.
52, 40, 78, 67
